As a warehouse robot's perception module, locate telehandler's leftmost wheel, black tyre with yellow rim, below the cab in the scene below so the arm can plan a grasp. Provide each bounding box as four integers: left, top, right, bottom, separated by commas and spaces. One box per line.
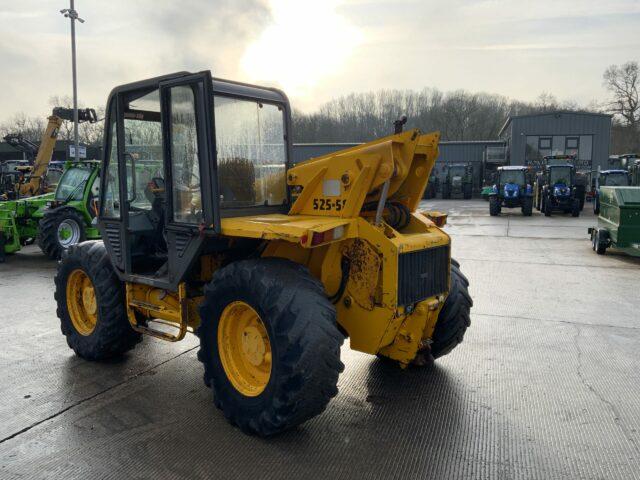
54, 241, 142, 360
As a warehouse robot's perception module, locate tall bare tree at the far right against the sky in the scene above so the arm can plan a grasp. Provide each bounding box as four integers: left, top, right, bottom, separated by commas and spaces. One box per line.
603, 62, 640, 131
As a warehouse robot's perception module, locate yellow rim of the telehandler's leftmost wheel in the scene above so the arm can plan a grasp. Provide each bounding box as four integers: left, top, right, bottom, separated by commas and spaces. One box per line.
67, 269, 98, 336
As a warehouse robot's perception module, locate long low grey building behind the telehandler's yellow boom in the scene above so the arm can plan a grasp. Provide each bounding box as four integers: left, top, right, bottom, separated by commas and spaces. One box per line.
293, 140, 506, 191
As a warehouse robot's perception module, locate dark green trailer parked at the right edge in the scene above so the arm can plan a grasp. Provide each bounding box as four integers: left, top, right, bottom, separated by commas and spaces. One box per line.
588, 187, 640, 256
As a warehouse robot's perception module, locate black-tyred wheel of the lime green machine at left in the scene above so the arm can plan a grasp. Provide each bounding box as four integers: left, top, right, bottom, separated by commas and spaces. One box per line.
38, 208, 86, 260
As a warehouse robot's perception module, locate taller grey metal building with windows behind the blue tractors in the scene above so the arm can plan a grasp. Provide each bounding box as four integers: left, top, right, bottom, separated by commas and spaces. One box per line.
499, 111, 611, 171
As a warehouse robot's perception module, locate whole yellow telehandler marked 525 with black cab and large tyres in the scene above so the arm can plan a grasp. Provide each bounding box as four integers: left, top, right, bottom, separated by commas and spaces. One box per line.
55, 71, 472, 435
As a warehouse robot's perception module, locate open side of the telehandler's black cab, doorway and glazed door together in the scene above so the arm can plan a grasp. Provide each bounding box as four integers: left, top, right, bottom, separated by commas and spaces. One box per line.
100, 71, 220, 290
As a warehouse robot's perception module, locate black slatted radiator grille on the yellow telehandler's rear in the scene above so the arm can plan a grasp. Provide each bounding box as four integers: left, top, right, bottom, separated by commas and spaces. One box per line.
398, 245, 449, 306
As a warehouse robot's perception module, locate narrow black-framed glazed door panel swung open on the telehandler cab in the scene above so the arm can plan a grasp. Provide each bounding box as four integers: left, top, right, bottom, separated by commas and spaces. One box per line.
160, 71, 220, 287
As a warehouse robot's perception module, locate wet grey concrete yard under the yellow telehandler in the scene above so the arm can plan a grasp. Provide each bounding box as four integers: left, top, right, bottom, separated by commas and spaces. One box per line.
0, 200, 640, 479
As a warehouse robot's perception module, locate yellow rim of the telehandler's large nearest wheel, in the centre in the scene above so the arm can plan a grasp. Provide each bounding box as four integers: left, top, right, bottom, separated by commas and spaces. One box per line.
218, 301, 272, 397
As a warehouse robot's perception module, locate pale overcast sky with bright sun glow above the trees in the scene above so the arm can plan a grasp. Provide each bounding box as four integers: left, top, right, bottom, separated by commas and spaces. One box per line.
0, 0, 640, 121
